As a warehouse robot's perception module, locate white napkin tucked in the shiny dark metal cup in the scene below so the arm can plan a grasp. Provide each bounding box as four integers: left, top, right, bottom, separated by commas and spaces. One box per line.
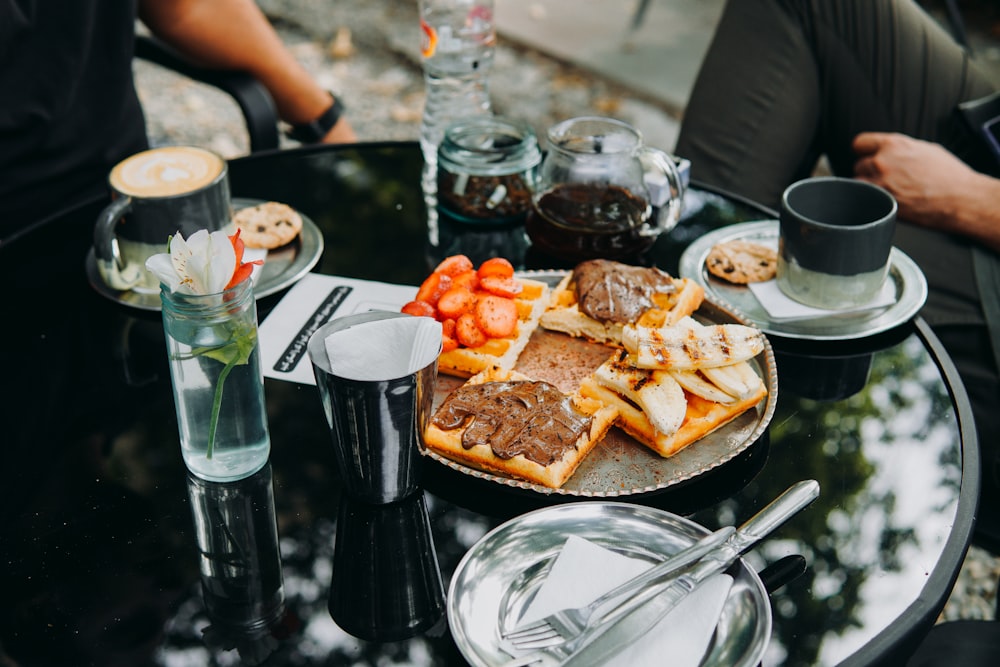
324, 316, 441, 381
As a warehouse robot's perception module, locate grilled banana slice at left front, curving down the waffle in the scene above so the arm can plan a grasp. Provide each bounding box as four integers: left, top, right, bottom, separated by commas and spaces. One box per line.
594, 358, 687, 435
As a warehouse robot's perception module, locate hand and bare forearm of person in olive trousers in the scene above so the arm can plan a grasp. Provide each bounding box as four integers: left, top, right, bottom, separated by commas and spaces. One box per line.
853, 132, 1000, 251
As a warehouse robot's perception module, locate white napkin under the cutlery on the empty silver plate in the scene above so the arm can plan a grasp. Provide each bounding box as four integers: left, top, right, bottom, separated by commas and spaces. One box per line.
518, 536, 733, 667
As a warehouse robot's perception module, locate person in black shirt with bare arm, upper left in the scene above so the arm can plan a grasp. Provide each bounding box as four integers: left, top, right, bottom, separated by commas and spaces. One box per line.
0, 0, 356, 243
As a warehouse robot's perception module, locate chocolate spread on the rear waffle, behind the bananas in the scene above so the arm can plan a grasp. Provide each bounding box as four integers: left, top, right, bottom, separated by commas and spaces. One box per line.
572, 259, 676, 324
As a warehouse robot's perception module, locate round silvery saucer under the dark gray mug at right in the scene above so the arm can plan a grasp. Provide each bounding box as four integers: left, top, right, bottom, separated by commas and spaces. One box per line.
680, 220, 927, 340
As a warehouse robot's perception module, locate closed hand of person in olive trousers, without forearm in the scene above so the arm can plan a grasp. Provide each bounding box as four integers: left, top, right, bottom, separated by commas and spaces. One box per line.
852, 132, 982, 230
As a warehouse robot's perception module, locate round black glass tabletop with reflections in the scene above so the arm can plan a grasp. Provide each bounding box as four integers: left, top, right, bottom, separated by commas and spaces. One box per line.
0, 143, 979, 665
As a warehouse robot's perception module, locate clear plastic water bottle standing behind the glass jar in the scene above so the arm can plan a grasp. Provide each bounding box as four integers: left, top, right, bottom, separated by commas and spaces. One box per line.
420, 0, 496, 245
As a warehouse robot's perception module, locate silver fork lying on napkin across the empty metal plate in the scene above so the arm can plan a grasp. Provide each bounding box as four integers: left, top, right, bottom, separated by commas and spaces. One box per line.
502, 526, 736, 651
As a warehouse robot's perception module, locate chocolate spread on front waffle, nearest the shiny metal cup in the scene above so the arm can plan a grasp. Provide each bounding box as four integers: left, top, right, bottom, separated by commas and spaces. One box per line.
433, 382, 591, 466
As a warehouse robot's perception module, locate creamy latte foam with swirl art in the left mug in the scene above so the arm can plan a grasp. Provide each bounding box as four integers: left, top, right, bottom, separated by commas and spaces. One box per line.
110, 146, 224, 197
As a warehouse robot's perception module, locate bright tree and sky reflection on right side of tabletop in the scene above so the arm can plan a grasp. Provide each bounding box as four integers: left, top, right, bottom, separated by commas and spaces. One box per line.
706, 336, 960, 665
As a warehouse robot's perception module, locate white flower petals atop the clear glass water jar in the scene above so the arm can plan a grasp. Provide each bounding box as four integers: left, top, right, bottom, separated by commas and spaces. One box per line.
146, 229, 239, 294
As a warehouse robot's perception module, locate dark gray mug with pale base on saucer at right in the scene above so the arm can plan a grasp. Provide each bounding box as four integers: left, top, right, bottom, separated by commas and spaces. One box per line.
777, 177, 897, 310
